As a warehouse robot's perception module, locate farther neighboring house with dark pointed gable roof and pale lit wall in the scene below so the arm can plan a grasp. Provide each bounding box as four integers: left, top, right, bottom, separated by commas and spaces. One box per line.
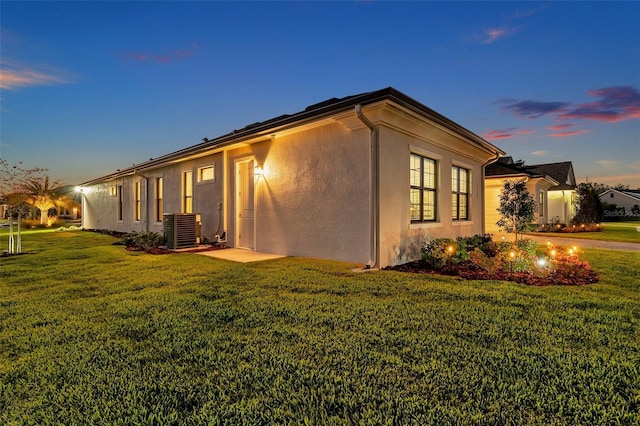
525, 161, 578, 225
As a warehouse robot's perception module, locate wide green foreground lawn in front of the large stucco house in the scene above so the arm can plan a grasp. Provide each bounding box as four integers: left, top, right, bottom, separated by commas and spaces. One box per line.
0, 231, 640, 425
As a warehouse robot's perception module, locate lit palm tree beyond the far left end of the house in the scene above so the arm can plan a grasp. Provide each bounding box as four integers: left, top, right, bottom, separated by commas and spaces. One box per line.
20, 176, 78, 225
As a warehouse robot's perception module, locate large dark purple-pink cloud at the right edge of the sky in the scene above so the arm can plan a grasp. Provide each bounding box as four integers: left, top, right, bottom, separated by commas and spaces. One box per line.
498, 86, 640, 123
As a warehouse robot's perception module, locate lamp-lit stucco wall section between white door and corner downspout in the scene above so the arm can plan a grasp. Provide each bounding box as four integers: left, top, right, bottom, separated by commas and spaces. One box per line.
228, 122, 369, 263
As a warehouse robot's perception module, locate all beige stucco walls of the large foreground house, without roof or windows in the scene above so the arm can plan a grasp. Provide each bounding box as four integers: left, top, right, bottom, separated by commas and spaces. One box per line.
83, 98, 496, 267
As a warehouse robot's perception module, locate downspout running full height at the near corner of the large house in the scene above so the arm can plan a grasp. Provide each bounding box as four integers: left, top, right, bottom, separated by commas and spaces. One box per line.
355, 104, 380, 269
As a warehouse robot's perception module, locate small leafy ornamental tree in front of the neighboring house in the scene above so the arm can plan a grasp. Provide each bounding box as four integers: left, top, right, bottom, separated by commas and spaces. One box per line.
496, 180, 537, 241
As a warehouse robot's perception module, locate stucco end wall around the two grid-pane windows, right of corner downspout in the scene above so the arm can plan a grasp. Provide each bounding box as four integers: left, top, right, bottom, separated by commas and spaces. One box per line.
379, 123, 488, 267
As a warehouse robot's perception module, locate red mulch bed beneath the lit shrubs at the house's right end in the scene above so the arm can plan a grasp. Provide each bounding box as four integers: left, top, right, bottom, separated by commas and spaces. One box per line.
384, 261, 598, 286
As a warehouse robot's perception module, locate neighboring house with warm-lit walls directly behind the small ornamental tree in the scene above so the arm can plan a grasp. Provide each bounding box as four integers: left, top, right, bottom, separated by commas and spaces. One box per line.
484, 157, 558, 234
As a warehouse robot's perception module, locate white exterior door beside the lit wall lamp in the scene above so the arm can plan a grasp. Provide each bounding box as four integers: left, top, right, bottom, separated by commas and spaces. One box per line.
236, 160, 255, 250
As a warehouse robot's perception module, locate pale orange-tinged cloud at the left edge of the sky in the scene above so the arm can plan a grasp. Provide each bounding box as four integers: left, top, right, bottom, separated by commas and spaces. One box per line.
0, 60, 71, 90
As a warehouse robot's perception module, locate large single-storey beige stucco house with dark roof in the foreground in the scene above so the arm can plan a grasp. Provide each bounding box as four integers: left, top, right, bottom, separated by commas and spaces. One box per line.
82, 88, 504, 267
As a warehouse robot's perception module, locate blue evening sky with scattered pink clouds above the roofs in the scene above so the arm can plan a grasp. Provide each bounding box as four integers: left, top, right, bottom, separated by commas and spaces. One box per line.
0, 1, 640, 188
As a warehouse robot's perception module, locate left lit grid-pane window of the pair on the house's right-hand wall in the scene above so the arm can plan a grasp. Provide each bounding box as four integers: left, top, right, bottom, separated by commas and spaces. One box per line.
409, 154, 436, 222
